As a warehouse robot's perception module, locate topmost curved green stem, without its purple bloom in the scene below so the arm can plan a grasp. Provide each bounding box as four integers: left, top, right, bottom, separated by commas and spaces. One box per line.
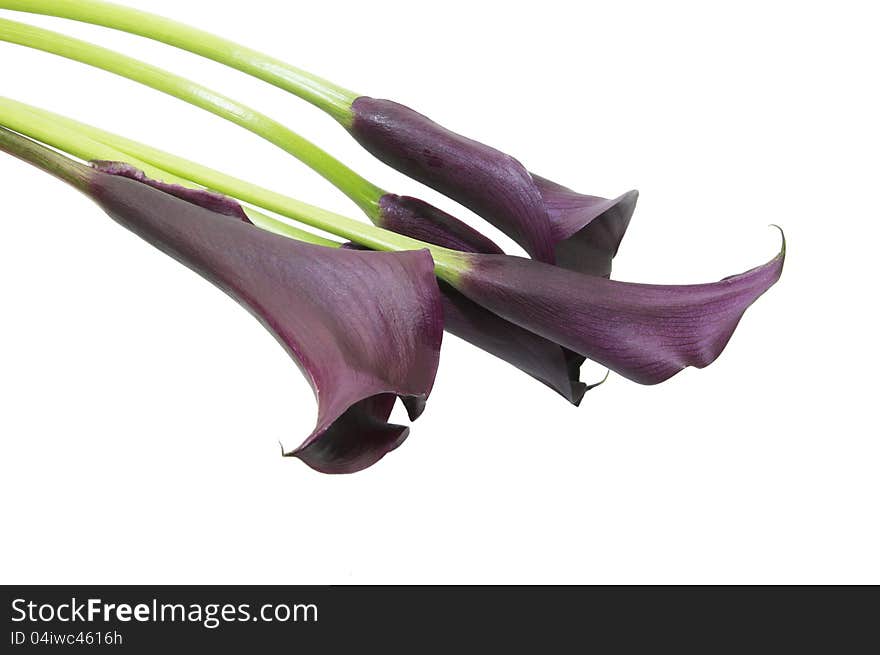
0, 0, 359, 126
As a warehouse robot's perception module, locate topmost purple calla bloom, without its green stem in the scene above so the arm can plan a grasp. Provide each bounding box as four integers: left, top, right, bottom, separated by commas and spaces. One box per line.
350, 96, 637, 275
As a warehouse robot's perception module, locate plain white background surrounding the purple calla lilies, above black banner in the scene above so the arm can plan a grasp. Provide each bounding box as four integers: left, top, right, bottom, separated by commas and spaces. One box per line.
0, 0, 880, 583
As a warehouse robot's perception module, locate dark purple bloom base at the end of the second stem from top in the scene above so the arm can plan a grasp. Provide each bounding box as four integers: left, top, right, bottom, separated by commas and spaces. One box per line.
379, 193, 504, 255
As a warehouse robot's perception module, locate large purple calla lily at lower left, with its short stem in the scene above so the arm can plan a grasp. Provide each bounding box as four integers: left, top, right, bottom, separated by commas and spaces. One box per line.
0, 128, 443, 473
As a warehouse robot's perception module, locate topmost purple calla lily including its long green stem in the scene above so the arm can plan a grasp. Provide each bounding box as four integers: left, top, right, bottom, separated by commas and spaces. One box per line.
0, 0, 638, 276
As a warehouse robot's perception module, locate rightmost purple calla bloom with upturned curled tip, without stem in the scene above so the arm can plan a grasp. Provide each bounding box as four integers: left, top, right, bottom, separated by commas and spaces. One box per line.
456, 241, 785, 384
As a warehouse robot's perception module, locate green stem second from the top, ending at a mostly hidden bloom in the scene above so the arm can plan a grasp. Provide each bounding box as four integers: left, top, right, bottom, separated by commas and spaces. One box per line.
0, 16, 385, 220
